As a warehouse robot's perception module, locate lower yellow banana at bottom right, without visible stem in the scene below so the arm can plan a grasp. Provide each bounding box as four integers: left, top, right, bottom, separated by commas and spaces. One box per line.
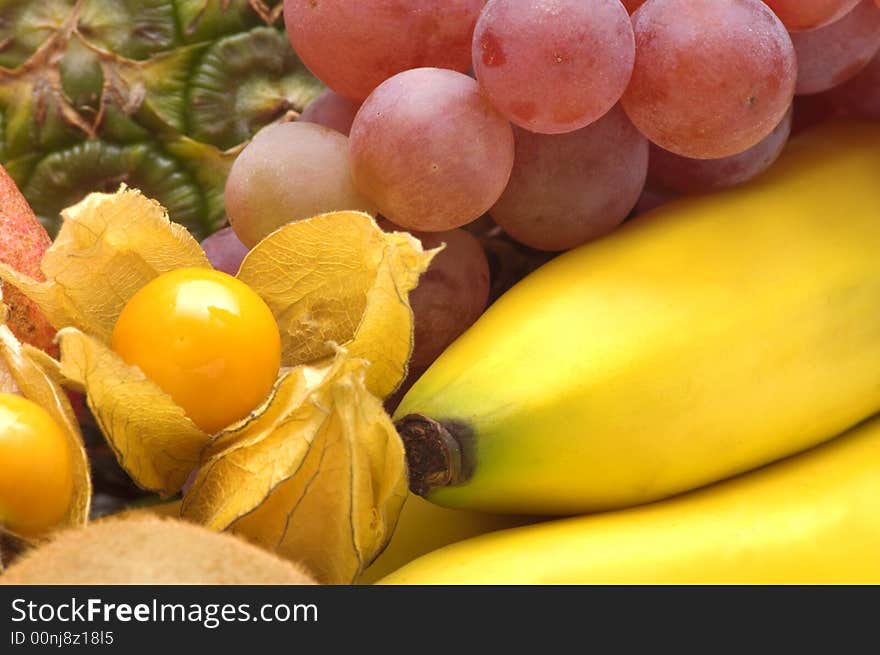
379, 418, 880, 584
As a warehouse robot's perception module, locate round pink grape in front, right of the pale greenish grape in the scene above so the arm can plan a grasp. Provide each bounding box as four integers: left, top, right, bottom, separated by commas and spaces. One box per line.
350, 68, 513, 232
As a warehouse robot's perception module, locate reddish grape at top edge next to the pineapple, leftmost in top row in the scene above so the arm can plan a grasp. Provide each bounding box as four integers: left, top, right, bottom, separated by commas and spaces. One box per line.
284, 0, 486, 101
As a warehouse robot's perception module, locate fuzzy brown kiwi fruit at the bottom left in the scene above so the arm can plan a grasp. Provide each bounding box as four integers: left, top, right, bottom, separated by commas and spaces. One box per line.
0, 515, 317, 585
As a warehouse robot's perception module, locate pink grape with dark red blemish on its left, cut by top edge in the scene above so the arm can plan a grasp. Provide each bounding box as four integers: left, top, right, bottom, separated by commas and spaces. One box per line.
473, 0, 635, 134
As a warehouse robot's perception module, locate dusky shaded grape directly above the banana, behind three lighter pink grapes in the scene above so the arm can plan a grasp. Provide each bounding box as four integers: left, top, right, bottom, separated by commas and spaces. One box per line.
489, 106, 648, 251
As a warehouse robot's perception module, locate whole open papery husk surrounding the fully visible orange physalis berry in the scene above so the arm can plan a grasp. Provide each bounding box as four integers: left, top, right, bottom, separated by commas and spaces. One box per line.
0, 188, 428, 582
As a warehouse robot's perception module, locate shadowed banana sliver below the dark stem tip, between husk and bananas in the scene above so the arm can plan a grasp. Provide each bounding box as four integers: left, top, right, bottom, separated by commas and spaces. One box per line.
357, 494, 539, 584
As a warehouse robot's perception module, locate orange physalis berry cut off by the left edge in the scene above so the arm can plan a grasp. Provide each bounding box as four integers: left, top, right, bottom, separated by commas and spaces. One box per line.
0, 393, 73, 537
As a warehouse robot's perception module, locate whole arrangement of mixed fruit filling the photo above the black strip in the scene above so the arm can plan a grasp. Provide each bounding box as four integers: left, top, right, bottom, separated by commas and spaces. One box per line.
0, 0, 880, 584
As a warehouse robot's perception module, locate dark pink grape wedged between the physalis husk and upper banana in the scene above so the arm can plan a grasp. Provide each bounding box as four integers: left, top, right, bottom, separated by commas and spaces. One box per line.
379, 220, 489, 369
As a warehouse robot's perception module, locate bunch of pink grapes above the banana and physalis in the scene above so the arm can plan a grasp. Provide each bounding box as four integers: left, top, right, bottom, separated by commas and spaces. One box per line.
215, 0, 880, 376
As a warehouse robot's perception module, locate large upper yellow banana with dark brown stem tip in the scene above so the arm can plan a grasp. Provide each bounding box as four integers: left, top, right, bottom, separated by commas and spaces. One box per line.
395, 124, 880, 514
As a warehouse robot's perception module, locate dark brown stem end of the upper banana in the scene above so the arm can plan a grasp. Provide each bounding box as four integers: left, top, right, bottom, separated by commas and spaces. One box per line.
395, 414, 473, 496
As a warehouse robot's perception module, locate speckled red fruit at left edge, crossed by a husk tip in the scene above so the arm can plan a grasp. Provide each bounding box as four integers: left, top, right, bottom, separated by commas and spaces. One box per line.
0, 166, 55, 354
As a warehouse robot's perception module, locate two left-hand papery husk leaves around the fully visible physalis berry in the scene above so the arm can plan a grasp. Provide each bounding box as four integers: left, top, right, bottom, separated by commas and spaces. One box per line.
0, 186, 210, 494
